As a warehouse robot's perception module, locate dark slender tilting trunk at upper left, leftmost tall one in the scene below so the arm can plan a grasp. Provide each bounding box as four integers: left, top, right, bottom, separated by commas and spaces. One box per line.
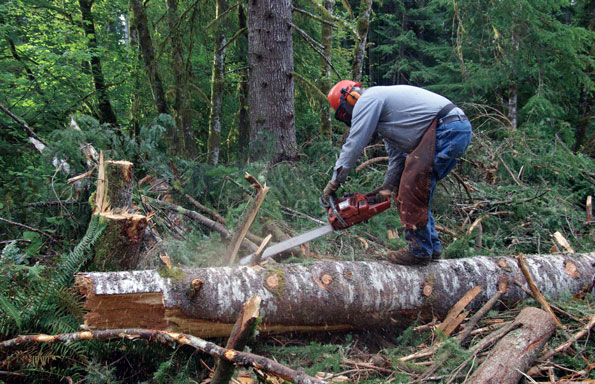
79, 0, 118, 127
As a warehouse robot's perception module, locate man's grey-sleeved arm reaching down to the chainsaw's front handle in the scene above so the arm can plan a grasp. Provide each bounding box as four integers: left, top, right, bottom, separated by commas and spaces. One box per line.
332, 94, 382, 183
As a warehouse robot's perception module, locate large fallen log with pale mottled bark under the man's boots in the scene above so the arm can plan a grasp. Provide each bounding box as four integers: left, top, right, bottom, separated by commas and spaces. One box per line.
76, 253, 595, 337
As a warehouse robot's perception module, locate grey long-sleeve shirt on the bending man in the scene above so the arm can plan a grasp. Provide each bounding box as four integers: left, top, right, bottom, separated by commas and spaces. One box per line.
333, 85, 463, 186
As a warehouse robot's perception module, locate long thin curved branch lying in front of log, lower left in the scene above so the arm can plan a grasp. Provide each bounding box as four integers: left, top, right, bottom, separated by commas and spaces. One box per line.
0, 329, 324, 384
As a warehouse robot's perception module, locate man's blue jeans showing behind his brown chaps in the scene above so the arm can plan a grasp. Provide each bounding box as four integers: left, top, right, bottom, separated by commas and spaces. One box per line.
405, 120, 471, 259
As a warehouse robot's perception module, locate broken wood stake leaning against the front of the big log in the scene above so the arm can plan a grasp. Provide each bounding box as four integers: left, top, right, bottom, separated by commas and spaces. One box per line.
211, 296, 262, 384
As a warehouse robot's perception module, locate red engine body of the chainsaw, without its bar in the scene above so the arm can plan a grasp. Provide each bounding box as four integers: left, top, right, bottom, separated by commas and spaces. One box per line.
328, 192, 390, 230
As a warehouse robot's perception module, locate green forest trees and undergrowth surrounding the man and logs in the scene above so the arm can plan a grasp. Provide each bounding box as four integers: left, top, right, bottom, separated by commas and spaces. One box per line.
0, 0, 595, 383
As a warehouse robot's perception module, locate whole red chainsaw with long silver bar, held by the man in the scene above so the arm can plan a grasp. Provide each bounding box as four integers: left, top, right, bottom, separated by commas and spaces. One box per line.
240, 192, 390, 265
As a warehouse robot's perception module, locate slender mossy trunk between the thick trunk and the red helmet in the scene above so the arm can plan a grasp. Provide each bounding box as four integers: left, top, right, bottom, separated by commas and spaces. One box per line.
319, 0, 335, 138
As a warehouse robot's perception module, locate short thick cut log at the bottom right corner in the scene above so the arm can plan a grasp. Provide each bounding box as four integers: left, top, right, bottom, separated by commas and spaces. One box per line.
467, 307, 556, 384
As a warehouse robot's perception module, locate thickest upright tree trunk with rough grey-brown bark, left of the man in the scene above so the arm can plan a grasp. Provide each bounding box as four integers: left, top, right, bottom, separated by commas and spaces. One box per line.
248, 0, 298, 162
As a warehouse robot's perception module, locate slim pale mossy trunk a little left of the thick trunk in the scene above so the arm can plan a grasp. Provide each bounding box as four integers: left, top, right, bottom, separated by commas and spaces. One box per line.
208, 0, 227, 165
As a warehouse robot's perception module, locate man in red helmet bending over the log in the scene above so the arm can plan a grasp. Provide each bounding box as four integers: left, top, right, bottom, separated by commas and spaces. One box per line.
323, 80, 471, 265
